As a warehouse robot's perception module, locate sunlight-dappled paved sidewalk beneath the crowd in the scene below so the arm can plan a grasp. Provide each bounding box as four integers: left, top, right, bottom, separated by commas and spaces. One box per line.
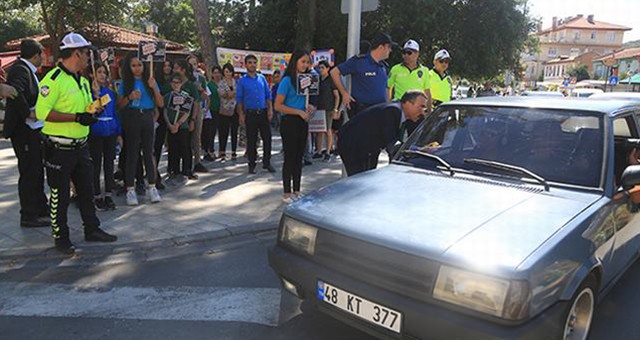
0, 136, 342, 260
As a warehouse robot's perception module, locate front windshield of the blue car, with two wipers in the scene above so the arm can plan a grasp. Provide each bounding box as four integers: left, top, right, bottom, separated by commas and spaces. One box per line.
396, 106, 604, 187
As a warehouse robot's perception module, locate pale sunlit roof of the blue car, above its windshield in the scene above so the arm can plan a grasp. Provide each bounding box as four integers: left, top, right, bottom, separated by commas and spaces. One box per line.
442, 96, 640, 115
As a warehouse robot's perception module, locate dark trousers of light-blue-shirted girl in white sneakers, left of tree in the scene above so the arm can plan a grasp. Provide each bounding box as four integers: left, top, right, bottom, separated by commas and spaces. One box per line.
124, 109, 156, 188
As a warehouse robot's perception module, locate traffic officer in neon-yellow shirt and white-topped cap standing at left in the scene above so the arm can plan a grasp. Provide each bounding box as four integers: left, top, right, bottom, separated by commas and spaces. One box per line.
36, 33, 117, 254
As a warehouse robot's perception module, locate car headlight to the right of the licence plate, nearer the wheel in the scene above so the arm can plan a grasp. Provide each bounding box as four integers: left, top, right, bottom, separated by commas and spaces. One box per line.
433, 266, 530, 320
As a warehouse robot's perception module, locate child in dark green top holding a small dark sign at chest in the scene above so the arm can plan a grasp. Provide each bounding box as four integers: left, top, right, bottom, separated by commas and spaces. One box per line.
163, 73, 193, 183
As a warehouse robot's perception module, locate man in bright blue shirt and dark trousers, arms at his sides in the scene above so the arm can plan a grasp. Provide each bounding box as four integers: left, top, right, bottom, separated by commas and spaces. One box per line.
236, 54, 276, 174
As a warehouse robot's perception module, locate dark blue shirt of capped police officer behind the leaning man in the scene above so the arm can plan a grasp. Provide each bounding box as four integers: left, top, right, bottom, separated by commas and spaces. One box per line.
338, 53, 388, 117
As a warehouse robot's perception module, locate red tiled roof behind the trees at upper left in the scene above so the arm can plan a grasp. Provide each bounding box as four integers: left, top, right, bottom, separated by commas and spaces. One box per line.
5, 23, 186, 51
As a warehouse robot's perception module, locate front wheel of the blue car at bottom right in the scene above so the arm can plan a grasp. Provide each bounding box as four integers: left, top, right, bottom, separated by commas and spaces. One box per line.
561, 275, 596, 340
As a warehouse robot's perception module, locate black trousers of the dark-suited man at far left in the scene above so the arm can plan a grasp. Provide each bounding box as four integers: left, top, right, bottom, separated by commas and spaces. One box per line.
11, 126, 49, 220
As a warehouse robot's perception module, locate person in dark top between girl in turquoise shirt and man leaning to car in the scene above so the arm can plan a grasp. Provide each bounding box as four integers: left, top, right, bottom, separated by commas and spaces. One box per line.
313, 60, 340, 161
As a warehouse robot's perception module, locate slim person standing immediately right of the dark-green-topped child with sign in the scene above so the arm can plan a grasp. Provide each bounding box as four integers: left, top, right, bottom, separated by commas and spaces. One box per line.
187, 55, 209, 173
